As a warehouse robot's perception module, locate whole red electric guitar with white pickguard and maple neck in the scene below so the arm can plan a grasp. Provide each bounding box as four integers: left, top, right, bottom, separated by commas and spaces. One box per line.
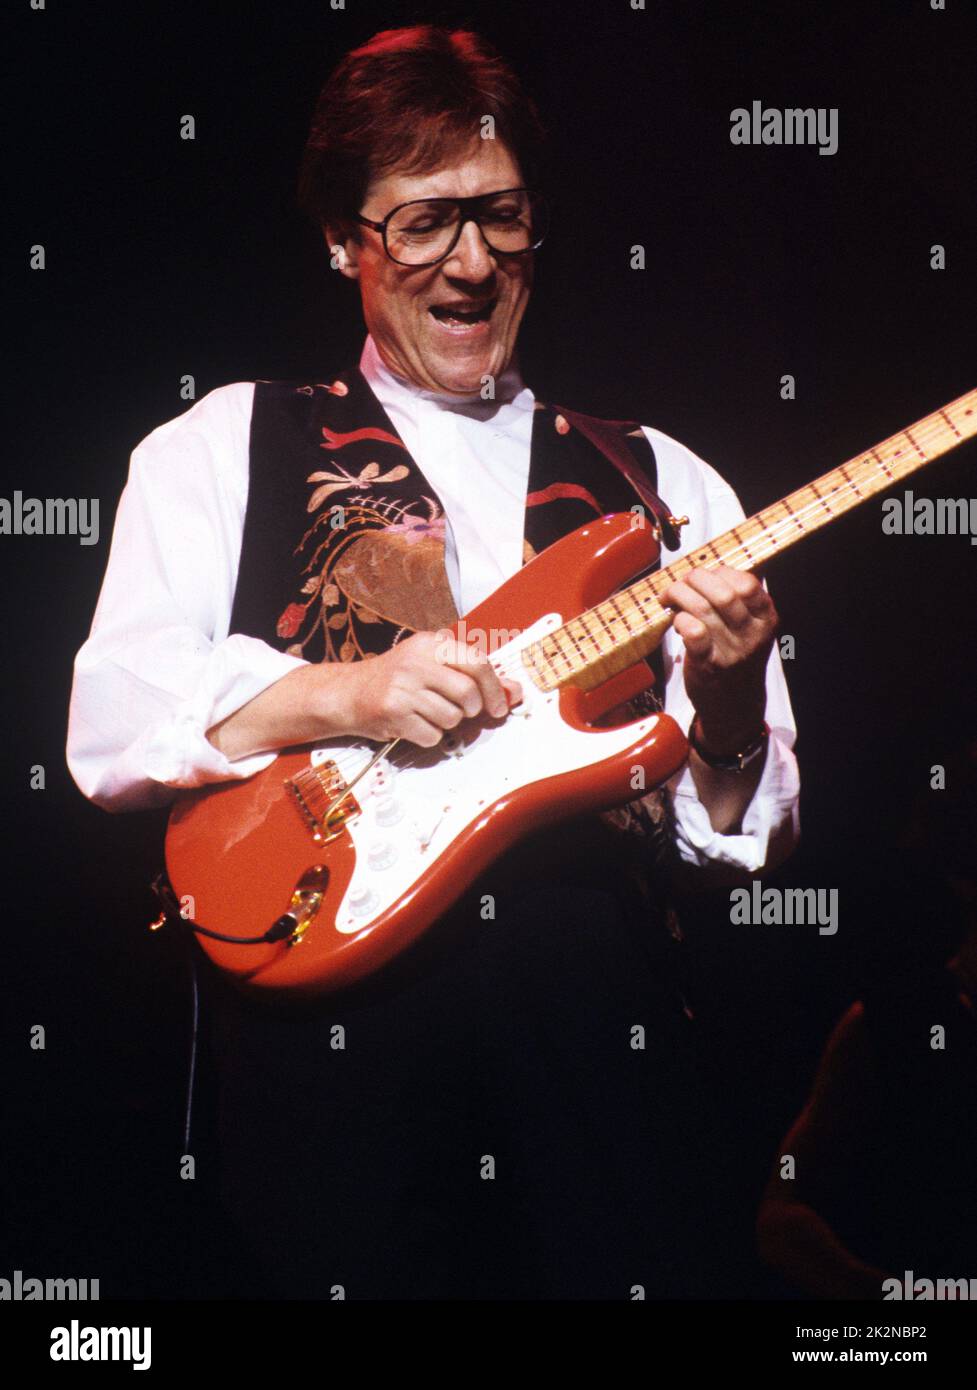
161, 391, 977, 994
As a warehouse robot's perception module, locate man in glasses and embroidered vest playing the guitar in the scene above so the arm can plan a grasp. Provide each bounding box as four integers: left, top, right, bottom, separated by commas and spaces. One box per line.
68, 25, 799, 1298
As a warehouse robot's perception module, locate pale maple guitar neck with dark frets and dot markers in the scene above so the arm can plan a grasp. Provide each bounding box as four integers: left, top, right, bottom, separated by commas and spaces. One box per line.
523, 389, 977, 691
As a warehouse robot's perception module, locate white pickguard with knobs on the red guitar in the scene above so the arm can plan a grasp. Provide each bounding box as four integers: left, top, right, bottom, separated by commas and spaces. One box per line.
311, 613, 659, 934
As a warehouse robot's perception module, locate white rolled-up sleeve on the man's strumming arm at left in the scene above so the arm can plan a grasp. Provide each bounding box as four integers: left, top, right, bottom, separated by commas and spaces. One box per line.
67, 382, 306, 810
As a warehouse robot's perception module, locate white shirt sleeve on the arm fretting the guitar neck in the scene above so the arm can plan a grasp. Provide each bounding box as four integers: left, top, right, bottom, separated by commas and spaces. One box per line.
645, 428, 801, 873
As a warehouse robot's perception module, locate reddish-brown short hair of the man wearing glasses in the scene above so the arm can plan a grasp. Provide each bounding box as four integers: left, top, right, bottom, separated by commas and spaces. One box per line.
297, 24, 546, 239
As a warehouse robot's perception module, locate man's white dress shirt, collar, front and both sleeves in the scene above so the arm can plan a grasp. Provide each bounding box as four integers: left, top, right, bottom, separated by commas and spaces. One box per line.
67, 338, 799, 873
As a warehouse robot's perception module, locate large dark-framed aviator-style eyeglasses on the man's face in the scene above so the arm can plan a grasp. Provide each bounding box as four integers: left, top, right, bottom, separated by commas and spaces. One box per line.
356, 188, 549, 265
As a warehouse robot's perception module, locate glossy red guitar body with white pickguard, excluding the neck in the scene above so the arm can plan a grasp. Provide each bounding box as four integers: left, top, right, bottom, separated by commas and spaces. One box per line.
165, 514, 688, 994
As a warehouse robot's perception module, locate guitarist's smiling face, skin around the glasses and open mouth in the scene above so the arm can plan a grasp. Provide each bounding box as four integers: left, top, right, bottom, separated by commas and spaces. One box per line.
334, 139, 532, 393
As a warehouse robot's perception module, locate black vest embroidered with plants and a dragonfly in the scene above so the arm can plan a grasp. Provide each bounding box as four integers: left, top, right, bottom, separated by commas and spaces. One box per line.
231, 367, 689, 945
